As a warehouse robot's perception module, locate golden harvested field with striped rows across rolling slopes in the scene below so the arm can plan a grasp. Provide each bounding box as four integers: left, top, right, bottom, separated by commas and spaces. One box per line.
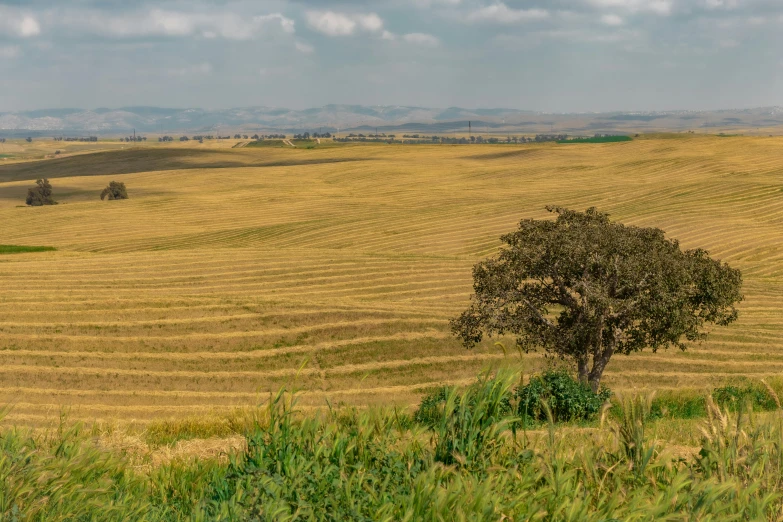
0, 136, 783, 425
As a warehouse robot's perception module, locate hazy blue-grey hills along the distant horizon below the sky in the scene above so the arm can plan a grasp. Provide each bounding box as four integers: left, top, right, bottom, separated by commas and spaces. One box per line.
0, 105, 783, 136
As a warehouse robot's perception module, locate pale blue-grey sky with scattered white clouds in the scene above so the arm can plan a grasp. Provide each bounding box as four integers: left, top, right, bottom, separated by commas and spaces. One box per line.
0, 0, 783, 112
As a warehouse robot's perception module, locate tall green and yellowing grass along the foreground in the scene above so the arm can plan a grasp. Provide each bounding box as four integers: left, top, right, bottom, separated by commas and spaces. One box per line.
7, 371, 783, 521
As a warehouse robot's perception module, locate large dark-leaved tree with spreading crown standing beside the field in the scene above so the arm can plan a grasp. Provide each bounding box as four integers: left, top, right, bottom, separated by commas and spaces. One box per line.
451, 207, 743, 391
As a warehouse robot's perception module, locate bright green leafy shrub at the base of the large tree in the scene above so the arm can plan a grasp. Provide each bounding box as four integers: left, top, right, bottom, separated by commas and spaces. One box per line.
515, 370, 612, 422
